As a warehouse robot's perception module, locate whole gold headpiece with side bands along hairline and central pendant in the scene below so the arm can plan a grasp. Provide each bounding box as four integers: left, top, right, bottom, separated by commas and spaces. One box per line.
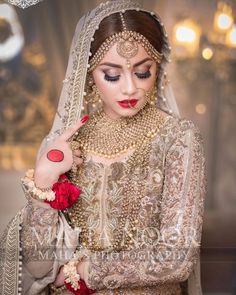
89, 12, 163, 72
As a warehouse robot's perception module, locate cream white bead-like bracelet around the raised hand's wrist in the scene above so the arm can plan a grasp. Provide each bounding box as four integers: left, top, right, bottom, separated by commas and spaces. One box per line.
22, 169, 56, 201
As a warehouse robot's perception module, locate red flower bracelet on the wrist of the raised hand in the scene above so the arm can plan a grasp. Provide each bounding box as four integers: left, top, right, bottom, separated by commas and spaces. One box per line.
44, 174, 81, 210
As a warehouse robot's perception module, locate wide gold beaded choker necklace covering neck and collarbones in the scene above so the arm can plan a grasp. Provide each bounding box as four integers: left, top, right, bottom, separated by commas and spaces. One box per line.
73, 105, 163, 159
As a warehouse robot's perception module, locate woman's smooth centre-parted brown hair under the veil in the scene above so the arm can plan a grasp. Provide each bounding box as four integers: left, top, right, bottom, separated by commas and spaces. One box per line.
91, 10, 164, 56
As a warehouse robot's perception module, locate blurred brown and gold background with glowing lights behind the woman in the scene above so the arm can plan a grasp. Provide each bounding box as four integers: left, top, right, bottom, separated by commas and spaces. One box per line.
0, 0, 236, 295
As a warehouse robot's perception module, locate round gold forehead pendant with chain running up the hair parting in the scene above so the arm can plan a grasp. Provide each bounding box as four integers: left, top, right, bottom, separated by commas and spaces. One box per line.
116, 12, 138, 69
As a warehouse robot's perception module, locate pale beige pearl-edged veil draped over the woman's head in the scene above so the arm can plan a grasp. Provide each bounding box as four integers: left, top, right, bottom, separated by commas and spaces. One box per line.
38, 0, 179, 160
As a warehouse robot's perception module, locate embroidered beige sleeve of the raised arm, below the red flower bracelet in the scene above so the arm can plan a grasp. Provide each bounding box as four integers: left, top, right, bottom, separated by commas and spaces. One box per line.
21, 182, 58, 279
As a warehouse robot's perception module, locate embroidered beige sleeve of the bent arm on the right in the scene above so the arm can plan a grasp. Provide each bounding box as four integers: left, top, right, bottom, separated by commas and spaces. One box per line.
87, 120, 206, 289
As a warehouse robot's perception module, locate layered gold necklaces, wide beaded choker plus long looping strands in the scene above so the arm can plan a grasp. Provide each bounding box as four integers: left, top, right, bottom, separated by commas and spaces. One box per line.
69, 104, 165, 251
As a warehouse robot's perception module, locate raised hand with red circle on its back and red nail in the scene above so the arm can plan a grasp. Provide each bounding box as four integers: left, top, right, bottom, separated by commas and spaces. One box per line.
34, 116, 88, 188
